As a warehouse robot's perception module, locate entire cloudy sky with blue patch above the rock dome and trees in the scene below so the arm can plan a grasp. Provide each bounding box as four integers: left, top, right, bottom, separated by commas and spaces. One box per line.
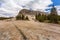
0, 0, 60, 17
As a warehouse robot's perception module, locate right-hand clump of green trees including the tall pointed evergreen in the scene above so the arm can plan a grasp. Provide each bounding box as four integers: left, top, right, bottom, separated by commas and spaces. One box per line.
35, 6, 60, 23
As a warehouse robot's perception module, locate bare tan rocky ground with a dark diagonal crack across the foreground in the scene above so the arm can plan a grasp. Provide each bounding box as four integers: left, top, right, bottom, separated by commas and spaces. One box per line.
0, 15, 60, 40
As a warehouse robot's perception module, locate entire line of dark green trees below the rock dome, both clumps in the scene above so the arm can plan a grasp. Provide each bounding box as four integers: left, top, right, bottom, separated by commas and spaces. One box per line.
16, 6, 60, 23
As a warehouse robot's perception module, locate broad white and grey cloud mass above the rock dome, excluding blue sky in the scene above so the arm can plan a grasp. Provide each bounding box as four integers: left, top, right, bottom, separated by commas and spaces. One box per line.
0, 0, 52, 16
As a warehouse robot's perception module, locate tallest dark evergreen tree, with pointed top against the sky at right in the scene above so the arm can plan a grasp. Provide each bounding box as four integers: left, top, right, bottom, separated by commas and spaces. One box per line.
48, 6, 58, 23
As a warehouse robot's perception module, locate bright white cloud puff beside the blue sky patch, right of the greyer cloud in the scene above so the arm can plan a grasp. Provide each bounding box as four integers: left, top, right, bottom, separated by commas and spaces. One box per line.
33, 0, 52, 10
